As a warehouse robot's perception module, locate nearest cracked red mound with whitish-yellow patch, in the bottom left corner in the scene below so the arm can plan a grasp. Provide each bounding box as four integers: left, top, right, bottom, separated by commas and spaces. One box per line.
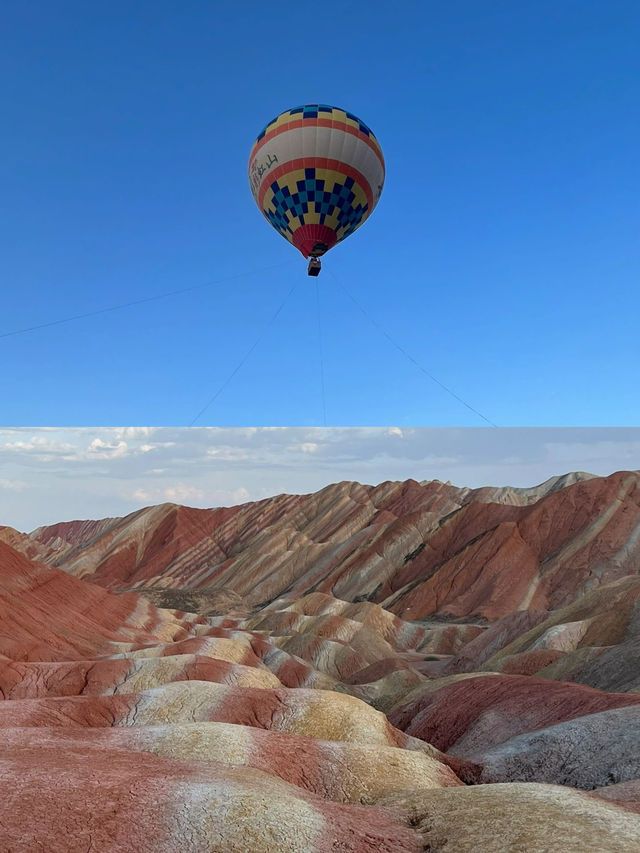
0, 747, 421, 853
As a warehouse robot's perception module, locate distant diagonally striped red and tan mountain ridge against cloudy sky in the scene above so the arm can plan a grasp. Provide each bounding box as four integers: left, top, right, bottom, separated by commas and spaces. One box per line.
16, 472, 640, 620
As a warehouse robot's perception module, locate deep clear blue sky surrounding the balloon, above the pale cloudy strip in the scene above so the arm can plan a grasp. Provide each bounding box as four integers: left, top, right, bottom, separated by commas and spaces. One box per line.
0, 0, 640, 427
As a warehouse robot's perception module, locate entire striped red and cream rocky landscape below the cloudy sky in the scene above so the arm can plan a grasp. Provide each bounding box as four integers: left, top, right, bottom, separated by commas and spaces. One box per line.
0, 472, 640, 853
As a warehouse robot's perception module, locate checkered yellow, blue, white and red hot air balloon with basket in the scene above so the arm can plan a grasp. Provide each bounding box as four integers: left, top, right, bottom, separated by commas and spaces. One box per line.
249, 104, 384, 275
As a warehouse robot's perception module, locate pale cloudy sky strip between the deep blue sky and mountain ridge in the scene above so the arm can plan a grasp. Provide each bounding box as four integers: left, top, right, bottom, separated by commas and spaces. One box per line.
0, 427, 640, 531
